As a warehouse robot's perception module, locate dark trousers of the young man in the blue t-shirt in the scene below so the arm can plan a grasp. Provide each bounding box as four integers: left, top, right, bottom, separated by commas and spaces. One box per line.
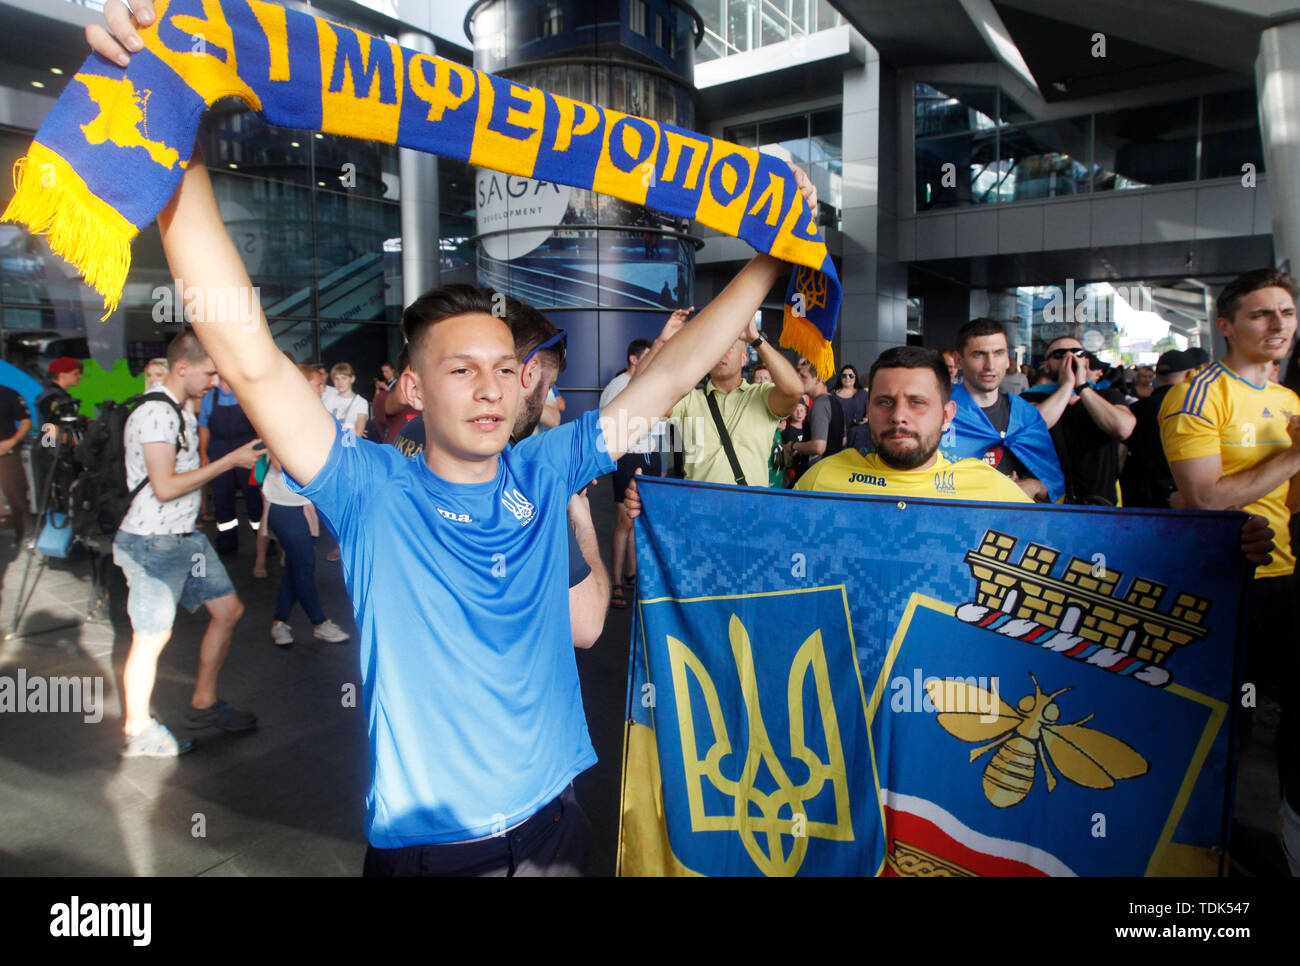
363, 785, 592, 878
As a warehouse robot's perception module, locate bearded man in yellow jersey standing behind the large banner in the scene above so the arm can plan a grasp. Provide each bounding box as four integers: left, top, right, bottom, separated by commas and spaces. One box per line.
794, 346, 1034, 503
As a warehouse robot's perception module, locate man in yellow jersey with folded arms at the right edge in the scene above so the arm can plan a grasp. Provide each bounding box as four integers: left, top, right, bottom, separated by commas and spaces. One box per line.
1160, 268, 1300, 875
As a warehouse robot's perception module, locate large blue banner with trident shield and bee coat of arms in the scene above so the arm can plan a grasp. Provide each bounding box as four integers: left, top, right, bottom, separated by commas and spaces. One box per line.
619, 478, 1251, 876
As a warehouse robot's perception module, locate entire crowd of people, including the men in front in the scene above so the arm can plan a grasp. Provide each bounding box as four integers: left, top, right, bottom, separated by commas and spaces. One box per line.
15, 7, 1300, 875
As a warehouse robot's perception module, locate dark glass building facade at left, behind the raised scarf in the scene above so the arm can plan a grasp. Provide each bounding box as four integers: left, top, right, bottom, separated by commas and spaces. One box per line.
0, 100, 475, 394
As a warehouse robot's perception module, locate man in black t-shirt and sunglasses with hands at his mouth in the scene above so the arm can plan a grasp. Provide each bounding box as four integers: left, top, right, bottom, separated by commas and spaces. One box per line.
1021, 335, 1138, 506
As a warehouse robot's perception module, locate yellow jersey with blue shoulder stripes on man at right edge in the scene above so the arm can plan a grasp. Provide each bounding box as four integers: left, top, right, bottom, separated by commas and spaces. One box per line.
1160, 363, 1300, 577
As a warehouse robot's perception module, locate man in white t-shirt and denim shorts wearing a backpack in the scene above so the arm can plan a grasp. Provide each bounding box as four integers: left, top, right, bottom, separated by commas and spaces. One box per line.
113, 332, 266, 758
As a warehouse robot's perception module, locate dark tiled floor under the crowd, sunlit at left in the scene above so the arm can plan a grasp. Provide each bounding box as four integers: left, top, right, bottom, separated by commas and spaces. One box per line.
0, 478, 1281, 875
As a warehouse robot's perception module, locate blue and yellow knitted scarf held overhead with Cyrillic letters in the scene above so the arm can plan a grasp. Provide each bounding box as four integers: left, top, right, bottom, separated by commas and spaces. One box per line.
3, 0, 840, 378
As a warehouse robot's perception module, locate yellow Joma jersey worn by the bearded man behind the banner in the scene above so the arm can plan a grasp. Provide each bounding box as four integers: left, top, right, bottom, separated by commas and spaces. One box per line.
794, 450, 1034, 503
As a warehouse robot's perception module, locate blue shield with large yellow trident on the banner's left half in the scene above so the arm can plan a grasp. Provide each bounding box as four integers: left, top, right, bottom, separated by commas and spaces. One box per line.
629, 588, 880, 876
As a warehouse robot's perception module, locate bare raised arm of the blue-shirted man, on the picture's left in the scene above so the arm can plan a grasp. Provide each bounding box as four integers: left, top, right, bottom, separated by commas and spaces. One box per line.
159, 151, 334, 482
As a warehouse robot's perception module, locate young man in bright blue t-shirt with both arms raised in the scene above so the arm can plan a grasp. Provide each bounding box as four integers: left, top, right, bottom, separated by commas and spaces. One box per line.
159, 153, 816, 875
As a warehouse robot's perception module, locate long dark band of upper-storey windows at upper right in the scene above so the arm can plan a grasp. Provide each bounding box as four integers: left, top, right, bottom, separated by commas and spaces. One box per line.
915, 83, 1264, 212
